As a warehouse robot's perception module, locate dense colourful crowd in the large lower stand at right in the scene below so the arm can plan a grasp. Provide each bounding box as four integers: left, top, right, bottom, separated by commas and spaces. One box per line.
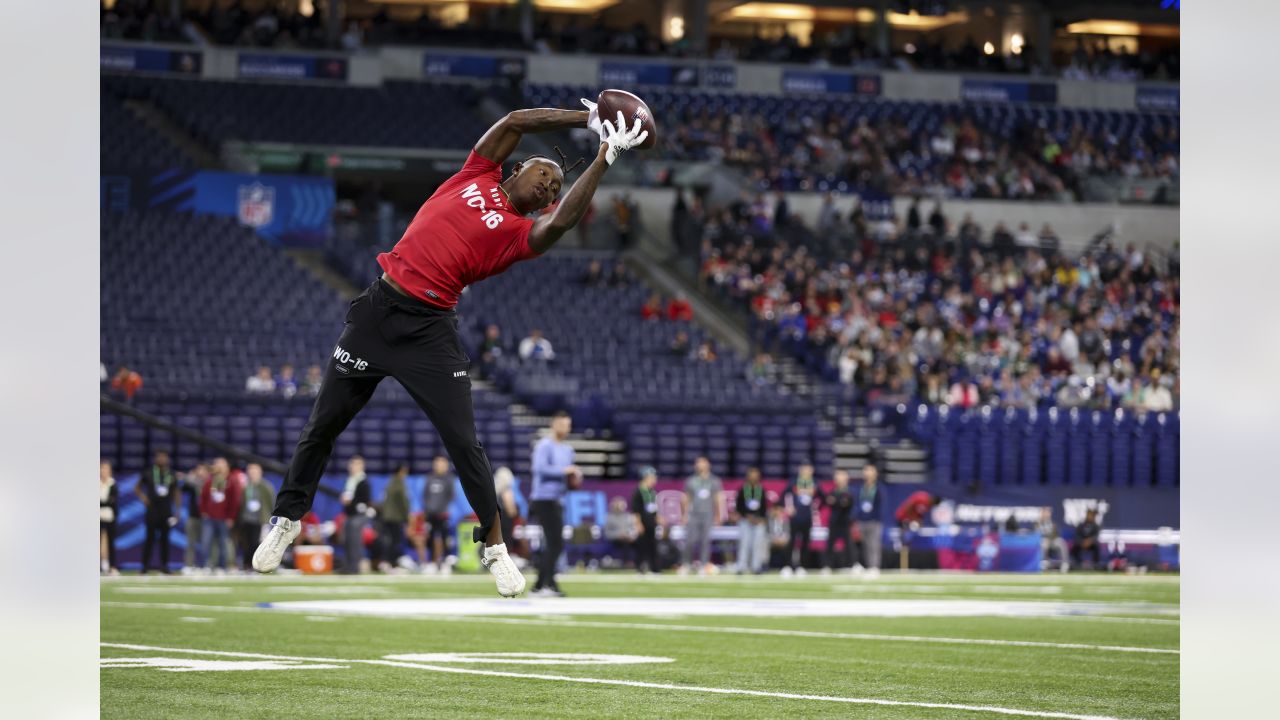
686, 194, 1180, 411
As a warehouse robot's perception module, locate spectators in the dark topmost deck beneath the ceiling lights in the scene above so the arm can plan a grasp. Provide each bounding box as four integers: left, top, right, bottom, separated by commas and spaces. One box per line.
101, 0, 1178, 81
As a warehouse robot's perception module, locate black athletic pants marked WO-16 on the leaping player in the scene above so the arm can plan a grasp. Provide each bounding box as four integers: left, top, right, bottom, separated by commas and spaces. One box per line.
274, 279, 498, 542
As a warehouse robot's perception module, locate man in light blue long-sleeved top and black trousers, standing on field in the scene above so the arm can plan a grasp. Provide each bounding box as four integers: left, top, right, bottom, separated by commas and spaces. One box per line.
529, 411, 582, 597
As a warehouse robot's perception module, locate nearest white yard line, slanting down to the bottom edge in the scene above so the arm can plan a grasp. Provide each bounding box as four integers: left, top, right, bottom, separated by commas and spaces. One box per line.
101, 643, 1141, 720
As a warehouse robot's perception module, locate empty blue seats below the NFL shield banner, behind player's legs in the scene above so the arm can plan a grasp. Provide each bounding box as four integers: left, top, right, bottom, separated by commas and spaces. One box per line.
101, 213, 530, 473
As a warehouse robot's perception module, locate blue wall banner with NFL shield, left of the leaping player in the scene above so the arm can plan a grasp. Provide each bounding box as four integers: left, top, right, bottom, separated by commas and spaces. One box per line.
100, 170, 335, 245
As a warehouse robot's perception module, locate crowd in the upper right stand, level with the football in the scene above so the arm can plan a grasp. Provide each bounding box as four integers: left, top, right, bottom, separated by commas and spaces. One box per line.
659, 99, 1179, 200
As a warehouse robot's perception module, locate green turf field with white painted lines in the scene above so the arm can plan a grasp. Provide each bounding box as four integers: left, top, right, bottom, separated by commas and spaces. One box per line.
101, 573, 1179, 719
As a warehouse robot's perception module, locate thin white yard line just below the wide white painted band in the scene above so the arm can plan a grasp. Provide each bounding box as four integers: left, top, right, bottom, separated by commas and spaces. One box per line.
102, 602, 1180, 655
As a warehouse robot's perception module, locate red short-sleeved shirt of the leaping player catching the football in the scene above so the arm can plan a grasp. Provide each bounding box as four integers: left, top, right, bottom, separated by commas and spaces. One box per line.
378, 150, 538, 309
